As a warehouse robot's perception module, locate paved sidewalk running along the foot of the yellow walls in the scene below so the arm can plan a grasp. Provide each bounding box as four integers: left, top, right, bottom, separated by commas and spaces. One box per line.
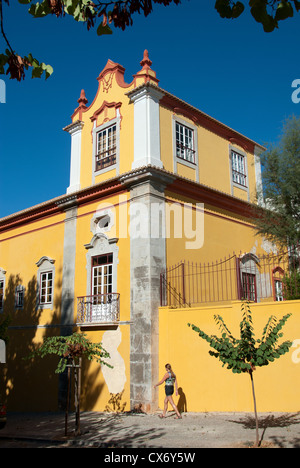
0, 412, 300, 449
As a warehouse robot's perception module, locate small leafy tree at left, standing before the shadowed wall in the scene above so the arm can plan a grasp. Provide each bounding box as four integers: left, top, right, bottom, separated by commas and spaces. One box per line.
27, 333, 112, 435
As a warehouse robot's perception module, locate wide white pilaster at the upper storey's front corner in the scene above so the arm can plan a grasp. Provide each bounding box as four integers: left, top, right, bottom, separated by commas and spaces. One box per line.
129, 86, 163, 169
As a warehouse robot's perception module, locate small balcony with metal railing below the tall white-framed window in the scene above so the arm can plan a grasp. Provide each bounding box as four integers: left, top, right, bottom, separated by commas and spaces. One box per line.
77, 293, 120, 326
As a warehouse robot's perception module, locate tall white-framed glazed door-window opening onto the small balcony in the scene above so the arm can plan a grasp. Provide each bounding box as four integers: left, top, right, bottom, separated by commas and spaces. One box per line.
92, 254, 113, 296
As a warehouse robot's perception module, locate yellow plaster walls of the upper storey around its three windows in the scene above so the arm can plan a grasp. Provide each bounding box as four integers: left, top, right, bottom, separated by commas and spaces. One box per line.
73, 67, 256, 205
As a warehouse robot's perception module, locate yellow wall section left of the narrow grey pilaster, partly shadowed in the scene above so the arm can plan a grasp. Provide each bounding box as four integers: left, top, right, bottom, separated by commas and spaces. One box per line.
0, 214, 64, 411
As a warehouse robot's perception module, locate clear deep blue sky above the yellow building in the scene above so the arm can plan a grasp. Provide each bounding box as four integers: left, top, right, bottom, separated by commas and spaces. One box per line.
0, 0, 300, 218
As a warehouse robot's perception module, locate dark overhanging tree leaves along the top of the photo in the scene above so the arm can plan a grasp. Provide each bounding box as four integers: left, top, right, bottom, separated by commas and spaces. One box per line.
0, 0, 300, 81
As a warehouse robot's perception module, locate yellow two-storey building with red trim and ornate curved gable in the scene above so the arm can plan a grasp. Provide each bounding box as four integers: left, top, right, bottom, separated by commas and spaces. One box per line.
0, 51, 292, 411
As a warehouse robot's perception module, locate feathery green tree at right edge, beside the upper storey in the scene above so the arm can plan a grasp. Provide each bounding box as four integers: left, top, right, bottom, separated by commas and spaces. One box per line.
254, 117, 300, 246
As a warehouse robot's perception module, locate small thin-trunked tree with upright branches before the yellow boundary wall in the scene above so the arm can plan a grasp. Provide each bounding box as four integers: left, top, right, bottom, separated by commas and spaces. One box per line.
188, 303, 292, 447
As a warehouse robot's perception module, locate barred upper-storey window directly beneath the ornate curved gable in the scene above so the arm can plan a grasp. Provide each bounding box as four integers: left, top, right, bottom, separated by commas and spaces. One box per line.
95, 125, 117, 171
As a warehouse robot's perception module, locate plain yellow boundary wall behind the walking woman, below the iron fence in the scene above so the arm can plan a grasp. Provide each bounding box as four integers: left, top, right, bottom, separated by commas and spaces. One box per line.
159, 301, 300, 412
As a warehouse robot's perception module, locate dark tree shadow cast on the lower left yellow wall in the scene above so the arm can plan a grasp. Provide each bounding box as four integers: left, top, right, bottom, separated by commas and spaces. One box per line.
0, 272, 104, 412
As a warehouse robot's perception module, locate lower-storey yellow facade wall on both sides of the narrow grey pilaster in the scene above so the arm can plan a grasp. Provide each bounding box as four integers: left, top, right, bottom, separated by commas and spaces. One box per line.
0, 192, 130, 411
